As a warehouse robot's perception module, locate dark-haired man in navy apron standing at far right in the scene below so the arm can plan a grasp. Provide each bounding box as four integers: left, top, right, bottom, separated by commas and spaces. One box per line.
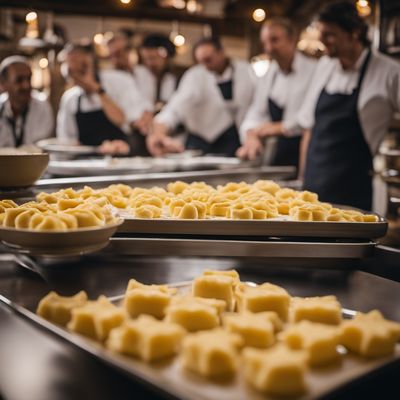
299, 1, 400, 210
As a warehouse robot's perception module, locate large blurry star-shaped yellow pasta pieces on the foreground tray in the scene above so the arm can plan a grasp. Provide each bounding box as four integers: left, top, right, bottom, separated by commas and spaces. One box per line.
37, 270, 400, 396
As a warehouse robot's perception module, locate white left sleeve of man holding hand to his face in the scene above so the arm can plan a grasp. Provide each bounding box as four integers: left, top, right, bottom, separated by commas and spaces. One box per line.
56, 92, 79, 142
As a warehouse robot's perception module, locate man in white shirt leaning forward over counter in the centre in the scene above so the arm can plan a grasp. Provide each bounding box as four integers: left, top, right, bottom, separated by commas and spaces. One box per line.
147, 38, 255, 156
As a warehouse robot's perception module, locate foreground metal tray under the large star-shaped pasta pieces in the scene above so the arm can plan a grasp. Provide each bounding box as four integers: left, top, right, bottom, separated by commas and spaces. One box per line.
0, 282, 400, 400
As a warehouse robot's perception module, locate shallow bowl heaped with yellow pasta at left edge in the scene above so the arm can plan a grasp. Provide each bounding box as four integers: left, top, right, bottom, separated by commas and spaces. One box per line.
0, 199, 122, 256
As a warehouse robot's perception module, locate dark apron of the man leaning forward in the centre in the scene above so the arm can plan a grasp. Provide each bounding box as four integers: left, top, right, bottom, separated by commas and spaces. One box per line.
185, 76, 240, 157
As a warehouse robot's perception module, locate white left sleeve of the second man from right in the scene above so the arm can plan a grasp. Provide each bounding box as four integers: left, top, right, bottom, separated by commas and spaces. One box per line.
239, 80, 271, 142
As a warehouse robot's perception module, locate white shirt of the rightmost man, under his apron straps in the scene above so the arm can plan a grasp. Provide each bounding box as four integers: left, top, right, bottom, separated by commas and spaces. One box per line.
298, 50, 400, 154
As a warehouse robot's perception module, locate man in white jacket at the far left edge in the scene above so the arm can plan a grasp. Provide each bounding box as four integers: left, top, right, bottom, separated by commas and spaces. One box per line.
0, 56, 54, 147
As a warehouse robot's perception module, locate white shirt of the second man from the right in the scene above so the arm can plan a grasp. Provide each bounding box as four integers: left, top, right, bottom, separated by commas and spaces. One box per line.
240, 51, 317, 142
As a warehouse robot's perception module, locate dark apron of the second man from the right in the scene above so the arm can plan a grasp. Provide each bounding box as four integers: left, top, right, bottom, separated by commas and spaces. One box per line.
268, 71, 301, 168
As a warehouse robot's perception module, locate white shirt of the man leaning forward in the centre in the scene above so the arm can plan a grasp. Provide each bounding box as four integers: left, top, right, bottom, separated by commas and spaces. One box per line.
155, 60, 255, 143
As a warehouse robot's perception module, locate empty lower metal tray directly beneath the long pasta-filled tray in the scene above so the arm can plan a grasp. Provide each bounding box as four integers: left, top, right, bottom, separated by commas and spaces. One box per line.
105, 236, 376, 259
